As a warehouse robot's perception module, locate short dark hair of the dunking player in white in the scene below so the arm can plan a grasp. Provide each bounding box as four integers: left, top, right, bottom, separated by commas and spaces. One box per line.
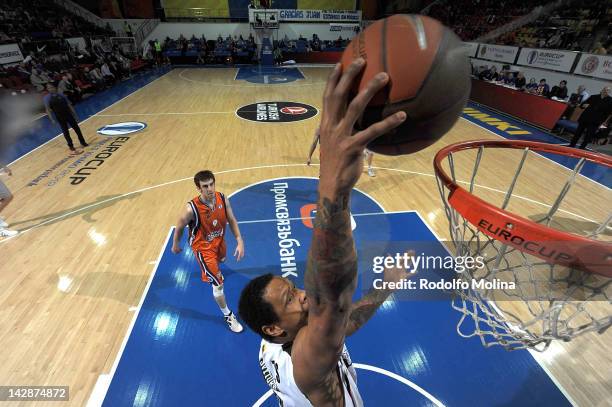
238, 273, 278, 341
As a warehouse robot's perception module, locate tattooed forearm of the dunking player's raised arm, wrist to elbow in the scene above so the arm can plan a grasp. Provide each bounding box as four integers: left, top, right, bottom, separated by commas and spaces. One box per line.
304, 189, 357, 304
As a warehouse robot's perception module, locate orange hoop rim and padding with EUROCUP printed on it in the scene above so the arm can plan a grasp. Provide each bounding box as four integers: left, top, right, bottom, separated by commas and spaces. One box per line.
434, 140, 612, 277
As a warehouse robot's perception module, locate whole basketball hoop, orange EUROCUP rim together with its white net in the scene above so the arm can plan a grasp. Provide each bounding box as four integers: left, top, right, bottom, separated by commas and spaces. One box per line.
434, 140, 612, 351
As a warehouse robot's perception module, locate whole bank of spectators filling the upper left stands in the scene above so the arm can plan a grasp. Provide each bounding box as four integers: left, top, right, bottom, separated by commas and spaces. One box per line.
0, 0, 145, 107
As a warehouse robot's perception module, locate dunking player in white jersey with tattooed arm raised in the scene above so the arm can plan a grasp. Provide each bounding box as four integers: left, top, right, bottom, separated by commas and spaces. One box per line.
239, 58, 407, 407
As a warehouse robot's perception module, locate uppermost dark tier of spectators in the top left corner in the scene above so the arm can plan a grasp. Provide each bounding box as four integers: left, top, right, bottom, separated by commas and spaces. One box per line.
0, 0, 114, 44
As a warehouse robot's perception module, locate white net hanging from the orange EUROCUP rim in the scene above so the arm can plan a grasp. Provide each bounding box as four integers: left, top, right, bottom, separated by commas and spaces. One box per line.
438, 142, 612, 351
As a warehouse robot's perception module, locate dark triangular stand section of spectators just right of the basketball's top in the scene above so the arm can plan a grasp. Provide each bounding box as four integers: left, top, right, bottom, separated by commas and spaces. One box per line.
428, 0, 542, 41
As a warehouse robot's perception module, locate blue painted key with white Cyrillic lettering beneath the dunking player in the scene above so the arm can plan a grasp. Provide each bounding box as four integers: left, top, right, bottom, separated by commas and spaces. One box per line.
104, 178, 569, 406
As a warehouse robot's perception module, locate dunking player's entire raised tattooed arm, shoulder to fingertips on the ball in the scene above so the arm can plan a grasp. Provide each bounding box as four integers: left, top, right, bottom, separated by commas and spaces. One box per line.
291, 59, 406, 405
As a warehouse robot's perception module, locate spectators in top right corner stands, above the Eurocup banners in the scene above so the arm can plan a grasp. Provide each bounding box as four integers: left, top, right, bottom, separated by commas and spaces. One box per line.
495, 0, 612, 54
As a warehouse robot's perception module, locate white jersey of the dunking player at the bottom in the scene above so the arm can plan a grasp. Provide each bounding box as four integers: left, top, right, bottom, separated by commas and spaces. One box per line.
259, 339, 363, 407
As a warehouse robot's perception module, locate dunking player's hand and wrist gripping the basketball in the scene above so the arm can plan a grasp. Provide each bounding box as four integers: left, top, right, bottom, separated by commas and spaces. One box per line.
320, 58, 406, 193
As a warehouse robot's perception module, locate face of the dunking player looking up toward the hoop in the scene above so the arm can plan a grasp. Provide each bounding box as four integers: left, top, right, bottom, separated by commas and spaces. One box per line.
263, 277, 308, 342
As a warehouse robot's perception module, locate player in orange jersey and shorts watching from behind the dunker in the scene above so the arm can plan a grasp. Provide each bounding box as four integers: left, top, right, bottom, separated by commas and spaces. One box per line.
172, 171, 244, 332
